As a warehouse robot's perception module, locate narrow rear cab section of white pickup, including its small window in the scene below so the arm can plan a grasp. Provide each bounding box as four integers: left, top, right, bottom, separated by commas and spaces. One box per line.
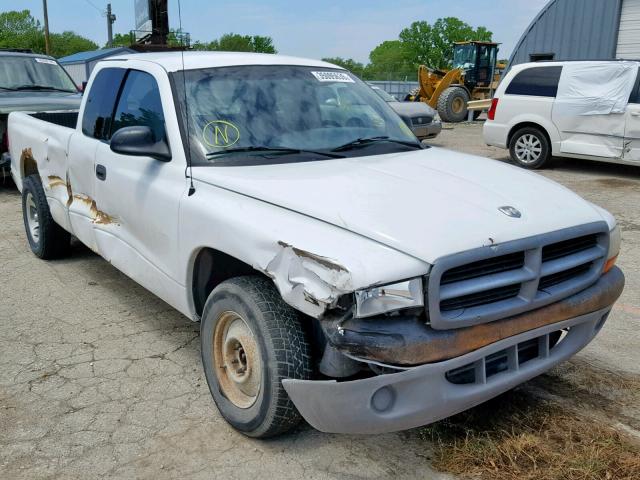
66, 68, 126, 251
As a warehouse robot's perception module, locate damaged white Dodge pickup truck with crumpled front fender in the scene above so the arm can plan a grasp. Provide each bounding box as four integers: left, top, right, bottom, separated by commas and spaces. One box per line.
9, 52, 624, 437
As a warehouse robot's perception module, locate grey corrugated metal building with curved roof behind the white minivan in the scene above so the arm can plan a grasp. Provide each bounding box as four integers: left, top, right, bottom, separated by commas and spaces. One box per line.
509, 0, 640, 66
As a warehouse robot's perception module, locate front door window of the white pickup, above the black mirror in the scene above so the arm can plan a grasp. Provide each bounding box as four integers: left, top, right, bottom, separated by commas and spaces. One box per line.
111, 70, 165, 140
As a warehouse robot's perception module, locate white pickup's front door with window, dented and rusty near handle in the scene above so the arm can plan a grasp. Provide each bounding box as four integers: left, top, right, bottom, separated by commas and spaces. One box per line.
95, 70, 187, 299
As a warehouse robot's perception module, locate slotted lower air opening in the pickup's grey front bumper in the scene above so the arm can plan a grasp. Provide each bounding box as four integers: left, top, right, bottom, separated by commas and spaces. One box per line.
445, 330, 562, 385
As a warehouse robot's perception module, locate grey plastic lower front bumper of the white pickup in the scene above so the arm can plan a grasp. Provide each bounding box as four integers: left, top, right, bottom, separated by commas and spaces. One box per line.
282, 268, 624, 434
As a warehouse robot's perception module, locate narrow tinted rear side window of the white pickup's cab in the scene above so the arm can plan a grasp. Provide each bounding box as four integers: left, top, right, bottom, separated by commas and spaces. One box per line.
82, 68, 127, 140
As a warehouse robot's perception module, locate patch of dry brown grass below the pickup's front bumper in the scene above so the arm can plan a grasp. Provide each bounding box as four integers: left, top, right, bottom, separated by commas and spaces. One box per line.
420, 376, 640, 480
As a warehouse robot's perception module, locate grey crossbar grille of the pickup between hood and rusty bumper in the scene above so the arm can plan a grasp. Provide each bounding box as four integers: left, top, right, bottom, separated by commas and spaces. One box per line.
427, 222, 609, 329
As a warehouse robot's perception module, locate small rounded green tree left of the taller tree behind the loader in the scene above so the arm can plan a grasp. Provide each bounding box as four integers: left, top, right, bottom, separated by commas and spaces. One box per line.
365, 40, 416, 80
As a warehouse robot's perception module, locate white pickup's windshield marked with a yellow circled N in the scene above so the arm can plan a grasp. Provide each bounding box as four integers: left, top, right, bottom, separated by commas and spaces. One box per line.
174, 65, 421, 165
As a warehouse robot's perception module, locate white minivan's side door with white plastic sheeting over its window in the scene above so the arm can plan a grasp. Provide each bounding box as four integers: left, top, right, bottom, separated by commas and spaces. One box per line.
552, 61, 640, 158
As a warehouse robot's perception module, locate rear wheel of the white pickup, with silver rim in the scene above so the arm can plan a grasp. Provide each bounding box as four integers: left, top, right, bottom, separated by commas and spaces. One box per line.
22, 175, 71, 260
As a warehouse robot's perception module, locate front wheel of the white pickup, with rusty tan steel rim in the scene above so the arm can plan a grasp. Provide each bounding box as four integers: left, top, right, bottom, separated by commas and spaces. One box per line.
200, 276, 312, 438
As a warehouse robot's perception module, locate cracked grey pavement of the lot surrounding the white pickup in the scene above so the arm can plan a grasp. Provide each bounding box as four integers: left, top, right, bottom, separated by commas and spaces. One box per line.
0, 123, 640, 480
